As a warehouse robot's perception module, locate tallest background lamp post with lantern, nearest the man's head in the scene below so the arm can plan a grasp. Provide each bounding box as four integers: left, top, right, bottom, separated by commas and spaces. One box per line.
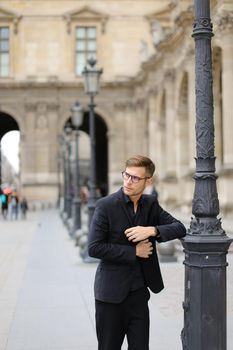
83, 58, 103, 226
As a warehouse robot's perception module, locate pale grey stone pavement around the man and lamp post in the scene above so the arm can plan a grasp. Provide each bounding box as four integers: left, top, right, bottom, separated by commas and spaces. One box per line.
0, 210, 233, 350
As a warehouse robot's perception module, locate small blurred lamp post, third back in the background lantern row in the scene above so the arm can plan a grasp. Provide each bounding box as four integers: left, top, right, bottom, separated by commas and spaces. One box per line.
64, 123, 72, 220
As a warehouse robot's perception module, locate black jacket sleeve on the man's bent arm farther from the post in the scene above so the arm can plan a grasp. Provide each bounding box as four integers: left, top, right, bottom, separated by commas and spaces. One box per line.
88, 201, 136, 263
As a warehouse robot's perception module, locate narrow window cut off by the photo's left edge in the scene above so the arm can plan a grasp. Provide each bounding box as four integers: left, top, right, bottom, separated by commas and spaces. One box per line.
0, 27, 9, 77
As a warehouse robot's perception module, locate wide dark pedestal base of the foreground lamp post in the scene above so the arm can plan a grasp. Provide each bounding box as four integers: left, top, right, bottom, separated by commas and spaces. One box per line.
181, 234, 232, 350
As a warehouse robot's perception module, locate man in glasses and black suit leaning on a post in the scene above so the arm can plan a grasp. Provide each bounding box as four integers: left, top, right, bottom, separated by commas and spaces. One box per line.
88, 155, 186, 350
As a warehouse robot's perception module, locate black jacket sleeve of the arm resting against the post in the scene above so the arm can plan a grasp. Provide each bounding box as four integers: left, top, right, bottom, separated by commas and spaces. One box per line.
156, 205, 186, 242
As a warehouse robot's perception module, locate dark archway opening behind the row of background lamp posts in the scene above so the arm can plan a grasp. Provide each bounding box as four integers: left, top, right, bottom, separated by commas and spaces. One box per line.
63, 111, 108, 195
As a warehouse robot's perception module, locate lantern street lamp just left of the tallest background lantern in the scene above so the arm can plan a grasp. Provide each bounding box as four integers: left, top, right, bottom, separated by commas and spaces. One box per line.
70, 102, 83, 236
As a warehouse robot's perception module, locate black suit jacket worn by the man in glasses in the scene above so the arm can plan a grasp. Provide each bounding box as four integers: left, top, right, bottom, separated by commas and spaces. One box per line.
88, 189, 186, 303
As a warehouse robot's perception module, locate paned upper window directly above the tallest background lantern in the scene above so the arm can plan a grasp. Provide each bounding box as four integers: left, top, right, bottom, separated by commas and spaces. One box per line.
76, 27, 96, 75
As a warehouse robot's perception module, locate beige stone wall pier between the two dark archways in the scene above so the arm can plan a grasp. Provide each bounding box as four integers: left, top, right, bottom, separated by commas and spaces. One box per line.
21, 102, 58, 203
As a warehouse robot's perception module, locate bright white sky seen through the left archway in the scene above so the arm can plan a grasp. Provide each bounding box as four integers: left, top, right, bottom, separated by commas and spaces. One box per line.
1, 131, 20, 172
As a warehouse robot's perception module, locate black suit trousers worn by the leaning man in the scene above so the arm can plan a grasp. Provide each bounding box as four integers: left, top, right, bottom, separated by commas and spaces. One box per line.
95, 287, 150, 350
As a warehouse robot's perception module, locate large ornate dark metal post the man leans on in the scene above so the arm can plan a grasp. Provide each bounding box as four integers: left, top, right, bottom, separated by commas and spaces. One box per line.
181, 0, 232, 350
